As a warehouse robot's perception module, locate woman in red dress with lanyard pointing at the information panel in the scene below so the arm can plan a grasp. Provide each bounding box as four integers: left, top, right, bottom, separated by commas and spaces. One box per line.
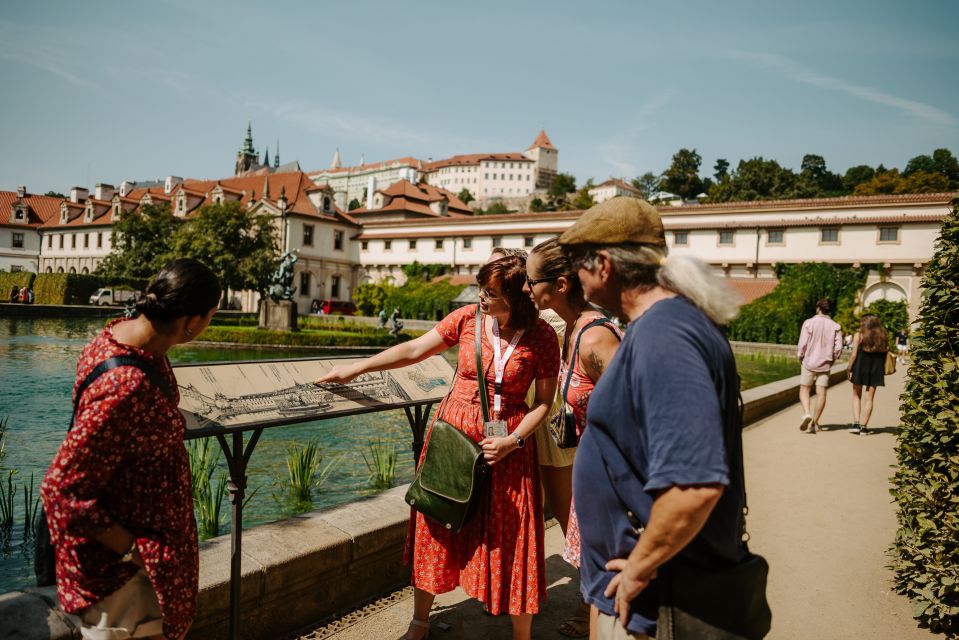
318, 256, 559, 640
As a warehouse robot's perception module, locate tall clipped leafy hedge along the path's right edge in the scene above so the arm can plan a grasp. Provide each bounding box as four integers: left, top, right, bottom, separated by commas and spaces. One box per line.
891, 201, 959, 637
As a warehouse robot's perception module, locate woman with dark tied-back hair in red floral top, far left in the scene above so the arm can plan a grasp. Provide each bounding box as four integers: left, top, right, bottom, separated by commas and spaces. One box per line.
40, 259, 220, 640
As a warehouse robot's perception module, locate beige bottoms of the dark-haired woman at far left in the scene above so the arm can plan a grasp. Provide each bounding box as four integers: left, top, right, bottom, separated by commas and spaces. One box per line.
80, 569, 163, 640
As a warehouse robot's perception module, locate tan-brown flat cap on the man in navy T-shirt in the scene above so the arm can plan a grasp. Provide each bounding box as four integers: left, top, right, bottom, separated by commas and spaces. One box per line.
559, 196, 666, 247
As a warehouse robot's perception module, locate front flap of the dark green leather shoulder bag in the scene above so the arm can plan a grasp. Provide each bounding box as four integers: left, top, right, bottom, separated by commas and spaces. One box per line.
419, 420, 483, 503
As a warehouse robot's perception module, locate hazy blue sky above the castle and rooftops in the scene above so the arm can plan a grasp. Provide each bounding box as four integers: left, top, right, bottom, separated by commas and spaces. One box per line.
0, 0, 959, 193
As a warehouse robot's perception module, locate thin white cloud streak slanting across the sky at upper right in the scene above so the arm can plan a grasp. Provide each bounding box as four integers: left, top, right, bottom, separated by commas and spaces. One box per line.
720, 50, 956, 126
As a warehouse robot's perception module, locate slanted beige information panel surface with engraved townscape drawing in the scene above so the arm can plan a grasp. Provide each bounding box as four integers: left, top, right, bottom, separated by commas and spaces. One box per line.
176, 356, 453, 429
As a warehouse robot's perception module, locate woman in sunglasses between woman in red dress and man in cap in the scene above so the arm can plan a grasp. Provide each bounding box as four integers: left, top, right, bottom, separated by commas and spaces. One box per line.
526, 238, 621, 638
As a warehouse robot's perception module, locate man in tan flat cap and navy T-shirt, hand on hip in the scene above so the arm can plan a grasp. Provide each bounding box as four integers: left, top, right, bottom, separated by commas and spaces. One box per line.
559, 198, 772, 639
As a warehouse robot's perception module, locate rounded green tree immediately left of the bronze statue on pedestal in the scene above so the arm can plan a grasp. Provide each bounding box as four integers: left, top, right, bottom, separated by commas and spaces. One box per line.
173, 202, 279, 300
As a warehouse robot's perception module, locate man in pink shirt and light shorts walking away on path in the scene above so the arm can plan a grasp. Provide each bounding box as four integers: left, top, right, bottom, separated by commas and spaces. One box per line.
797, 298, 842, 433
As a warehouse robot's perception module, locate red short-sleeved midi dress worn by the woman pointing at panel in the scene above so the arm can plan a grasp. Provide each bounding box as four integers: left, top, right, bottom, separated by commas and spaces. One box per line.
408, 306, 559, 615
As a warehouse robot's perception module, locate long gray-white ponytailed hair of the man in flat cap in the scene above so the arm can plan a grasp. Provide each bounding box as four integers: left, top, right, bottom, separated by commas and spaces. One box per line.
576, 244, 741, 325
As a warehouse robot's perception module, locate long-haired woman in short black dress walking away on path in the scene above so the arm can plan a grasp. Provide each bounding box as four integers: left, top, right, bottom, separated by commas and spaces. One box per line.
848, 313, 889, 436
